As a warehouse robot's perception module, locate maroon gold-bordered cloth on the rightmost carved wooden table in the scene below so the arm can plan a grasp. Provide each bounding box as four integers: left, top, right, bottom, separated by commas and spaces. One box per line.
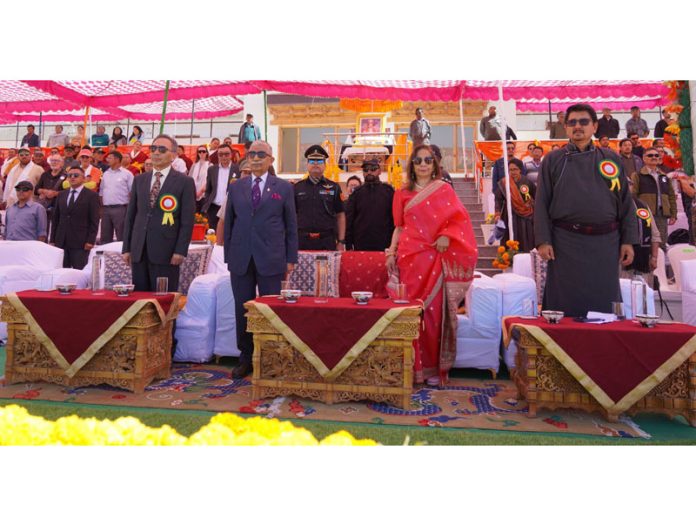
503, 317, 696, 412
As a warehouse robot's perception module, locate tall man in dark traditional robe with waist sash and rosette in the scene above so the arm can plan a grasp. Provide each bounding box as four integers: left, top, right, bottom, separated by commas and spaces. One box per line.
534, 104, 639, 317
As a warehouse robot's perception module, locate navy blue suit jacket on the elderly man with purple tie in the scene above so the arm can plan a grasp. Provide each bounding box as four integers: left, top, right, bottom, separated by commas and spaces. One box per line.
224, 174, 297, 275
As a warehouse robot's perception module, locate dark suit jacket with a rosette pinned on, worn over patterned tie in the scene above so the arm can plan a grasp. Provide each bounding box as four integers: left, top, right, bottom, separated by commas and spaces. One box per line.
122, 169, 196, 264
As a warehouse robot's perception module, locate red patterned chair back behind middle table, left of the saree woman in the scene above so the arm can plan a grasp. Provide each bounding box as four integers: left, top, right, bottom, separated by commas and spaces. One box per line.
338, 251, 389, 298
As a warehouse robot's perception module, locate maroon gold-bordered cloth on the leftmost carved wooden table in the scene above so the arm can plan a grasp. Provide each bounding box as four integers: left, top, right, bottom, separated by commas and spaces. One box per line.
7, 290, 180, 377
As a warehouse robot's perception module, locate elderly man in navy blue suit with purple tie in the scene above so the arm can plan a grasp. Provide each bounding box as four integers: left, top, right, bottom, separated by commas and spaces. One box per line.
224, 140, 297, 379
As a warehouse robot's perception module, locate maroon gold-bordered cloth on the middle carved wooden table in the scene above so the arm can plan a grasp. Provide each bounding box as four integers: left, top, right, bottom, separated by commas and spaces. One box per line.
251, 297, 420, 381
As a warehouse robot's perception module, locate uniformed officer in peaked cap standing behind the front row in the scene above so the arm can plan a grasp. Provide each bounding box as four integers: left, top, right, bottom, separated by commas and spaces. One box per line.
295, 144, 346, 251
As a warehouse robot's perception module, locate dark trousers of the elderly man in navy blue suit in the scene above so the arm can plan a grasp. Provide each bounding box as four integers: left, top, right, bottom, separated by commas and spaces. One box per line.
230, 258, 285, 364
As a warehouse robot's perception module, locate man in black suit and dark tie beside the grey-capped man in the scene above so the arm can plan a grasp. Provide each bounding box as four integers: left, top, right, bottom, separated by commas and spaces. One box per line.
51, 166, 99, 270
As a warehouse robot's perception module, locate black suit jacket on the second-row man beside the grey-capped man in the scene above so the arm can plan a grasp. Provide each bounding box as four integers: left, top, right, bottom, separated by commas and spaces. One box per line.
51, 186, 99, 250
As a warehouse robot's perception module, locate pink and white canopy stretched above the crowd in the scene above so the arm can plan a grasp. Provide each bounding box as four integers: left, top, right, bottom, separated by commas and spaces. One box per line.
0, 80, 668, 122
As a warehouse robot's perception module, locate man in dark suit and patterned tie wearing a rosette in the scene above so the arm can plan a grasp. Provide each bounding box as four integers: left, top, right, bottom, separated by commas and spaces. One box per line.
123, 135, 196, 292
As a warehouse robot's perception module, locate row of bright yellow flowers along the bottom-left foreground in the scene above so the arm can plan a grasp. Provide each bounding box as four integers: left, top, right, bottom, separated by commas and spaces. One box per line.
0, 405, 377, 446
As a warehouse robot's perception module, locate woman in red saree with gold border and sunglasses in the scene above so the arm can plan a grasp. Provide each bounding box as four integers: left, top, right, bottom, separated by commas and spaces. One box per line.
386, 145, 478, 385
